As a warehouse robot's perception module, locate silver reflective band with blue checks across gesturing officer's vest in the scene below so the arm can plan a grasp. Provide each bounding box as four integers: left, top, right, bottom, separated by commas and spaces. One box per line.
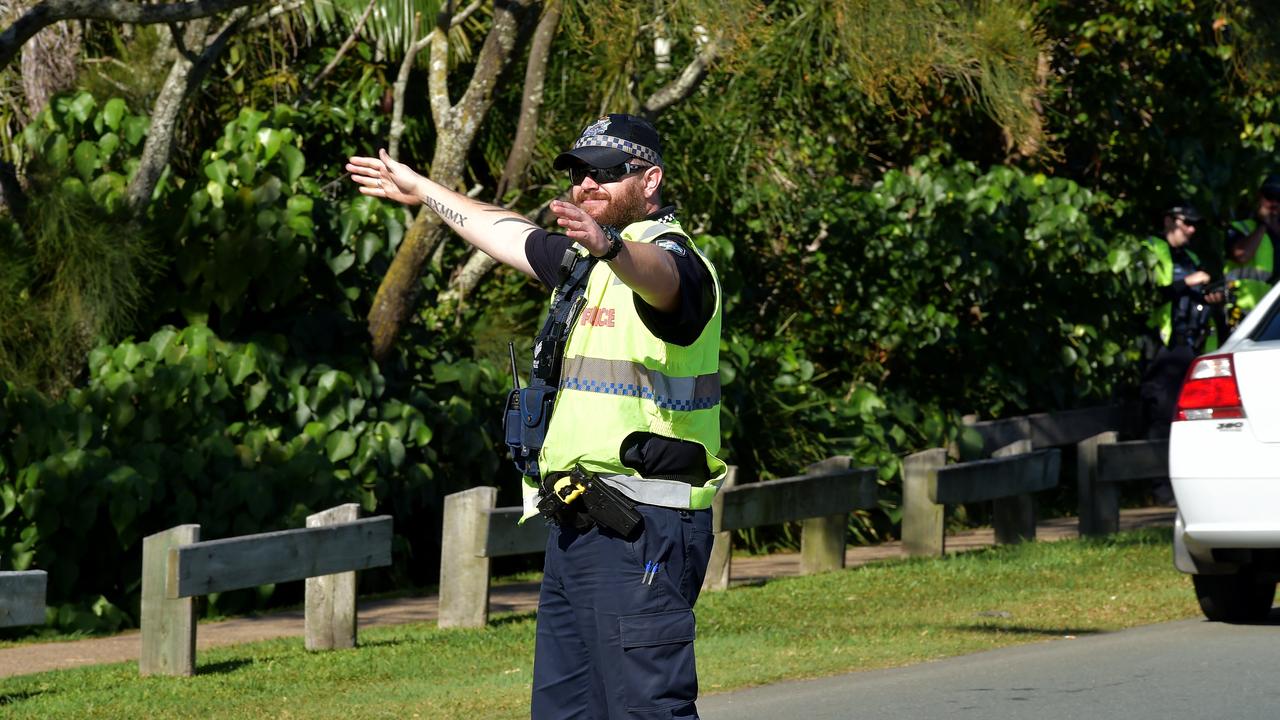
561, 356, 719, 411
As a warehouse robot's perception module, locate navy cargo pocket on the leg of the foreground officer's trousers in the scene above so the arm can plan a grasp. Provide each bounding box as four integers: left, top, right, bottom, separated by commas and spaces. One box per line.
618, 610, 698, 712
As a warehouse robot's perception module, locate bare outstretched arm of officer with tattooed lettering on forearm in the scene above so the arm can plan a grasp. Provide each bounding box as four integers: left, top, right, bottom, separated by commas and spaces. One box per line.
347, 150, 538, 278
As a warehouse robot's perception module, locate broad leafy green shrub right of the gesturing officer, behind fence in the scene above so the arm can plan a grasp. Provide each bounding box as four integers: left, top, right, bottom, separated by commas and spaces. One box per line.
707, 152, 1149, 537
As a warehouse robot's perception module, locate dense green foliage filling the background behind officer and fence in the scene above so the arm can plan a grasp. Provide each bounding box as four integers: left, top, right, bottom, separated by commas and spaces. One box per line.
0, 0, 1280, 628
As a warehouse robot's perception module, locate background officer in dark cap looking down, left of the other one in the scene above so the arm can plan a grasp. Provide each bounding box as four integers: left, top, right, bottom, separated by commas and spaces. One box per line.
1139, 204, 1211, 505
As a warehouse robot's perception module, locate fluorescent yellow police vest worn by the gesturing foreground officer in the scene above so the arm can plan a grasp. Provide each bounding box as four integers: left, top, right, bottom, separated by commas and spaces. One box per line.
525, 220, 727, 518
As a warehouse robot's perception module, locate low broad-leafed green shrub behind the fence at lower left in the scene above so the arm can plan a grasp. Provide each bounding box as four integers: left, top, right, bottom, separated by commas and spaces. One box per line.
0, 319, 504, 626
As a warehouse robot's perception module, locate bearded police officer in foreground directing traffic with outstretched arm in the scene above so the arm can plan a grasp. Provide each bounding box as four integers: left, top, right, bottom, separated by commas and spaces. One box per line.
347, 114, 727, 720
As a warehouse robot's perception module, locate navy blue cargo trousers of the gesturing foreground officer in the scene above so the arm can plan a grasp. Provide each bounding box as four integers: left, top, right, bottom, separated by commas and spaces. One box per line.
532, 505, 712, 720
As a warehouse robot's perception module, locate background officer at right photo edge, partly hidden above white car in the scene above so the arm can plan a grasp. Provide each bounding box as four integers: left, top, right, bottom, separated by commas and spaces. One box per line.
1210, 174, 1280, 340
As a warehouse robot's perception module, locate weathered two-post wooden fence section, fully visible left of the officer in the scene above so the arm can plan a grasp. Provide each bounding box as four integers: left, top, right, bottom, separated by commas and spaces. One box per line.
138, 503, 392, 675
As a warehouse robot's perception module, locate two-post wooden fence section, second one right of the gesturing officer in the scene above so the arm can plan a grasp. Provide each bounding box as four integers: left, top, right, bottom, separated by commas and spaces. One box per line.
902, 439, 1061, 556
